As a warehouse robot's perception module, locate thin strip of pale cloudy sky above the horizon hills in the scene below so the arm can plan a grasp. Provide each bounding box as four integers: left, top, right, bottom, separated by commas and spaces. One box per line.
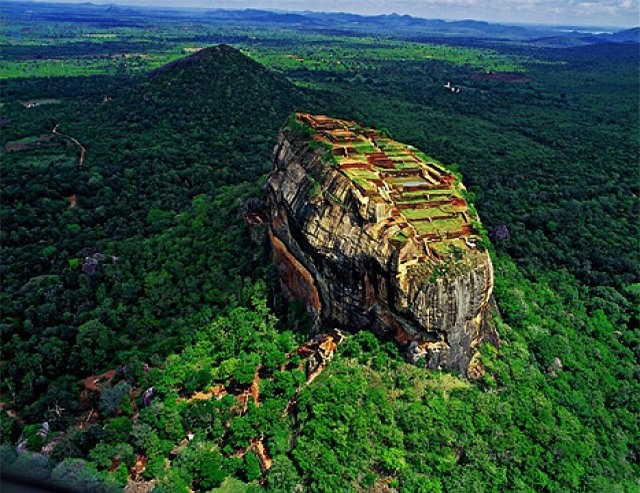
30, 0, 640, 28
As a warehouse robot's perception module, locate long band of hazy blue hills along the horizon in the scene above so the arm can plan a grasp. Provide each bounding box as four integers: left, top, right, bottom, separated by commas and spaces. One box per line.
0, 1, 638, 47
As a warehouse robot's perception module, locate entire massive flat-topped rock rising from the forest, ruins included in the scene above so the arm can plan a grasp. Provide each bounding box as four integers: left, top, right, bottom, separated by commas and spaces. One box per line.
267, 114, 498, 376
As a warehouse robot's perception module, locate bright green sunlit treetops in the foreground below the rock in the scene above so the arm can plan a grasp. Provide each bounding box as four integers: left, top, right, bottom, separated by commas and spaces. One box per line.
5, 258, 640, 492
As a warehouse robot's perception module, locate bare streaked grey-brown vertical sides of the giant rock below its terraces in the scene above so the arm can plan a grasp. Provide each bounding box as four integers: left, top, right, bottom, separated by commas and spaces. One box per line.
267, 114, 499, 373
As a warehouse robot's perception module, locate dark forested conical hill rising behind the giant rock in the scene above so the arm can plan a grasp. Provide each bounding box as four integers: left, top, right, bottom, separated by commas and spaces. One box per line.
140, 45, 306, 182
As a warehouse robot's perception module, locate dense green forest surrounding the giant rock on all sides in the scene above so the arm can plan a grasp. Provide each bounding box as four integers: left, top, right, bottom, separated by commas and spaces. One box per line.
0, 4, 640, 493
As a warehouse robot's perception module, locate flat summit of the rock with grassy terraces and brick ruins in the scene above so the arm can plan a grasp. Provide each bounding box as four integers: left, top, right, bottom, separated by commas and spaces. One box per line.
297, 113, 478, 257
